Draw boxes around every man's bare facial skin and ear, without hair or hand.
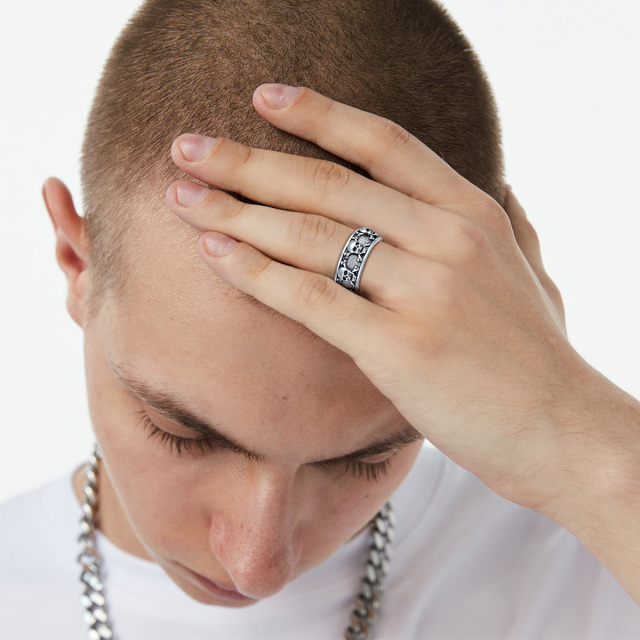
[45,181,422,607]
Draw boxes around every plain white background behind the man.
[0,0,640,499]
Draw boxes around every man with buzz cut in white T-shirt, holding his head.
[3,2,640,640]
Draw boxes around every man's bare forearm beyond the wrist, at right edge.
[547,367,640,604]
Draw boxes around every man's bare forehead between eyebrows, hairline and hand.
[100,218,402,457]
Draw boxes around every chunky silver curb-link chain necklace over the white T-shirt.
[78,446,395,640]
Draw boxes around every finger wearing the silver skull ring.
[167,181,415,306]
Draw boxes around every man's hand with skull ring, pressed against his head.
[167,87,586,510]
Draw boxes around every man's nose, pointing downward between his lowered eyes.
[209,465,301,598]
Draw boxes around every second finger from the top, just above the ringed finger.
[172,134,441,248]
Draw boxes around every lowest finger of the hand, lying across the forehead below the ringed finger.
[198,232,393,362]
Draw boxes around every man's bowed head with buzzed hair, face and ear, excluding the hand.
[47,0,502,605]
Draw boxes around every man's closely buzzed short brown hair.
[82,0,504,310]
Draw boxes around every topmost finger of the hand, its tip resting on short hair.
[253,85,479,204]
